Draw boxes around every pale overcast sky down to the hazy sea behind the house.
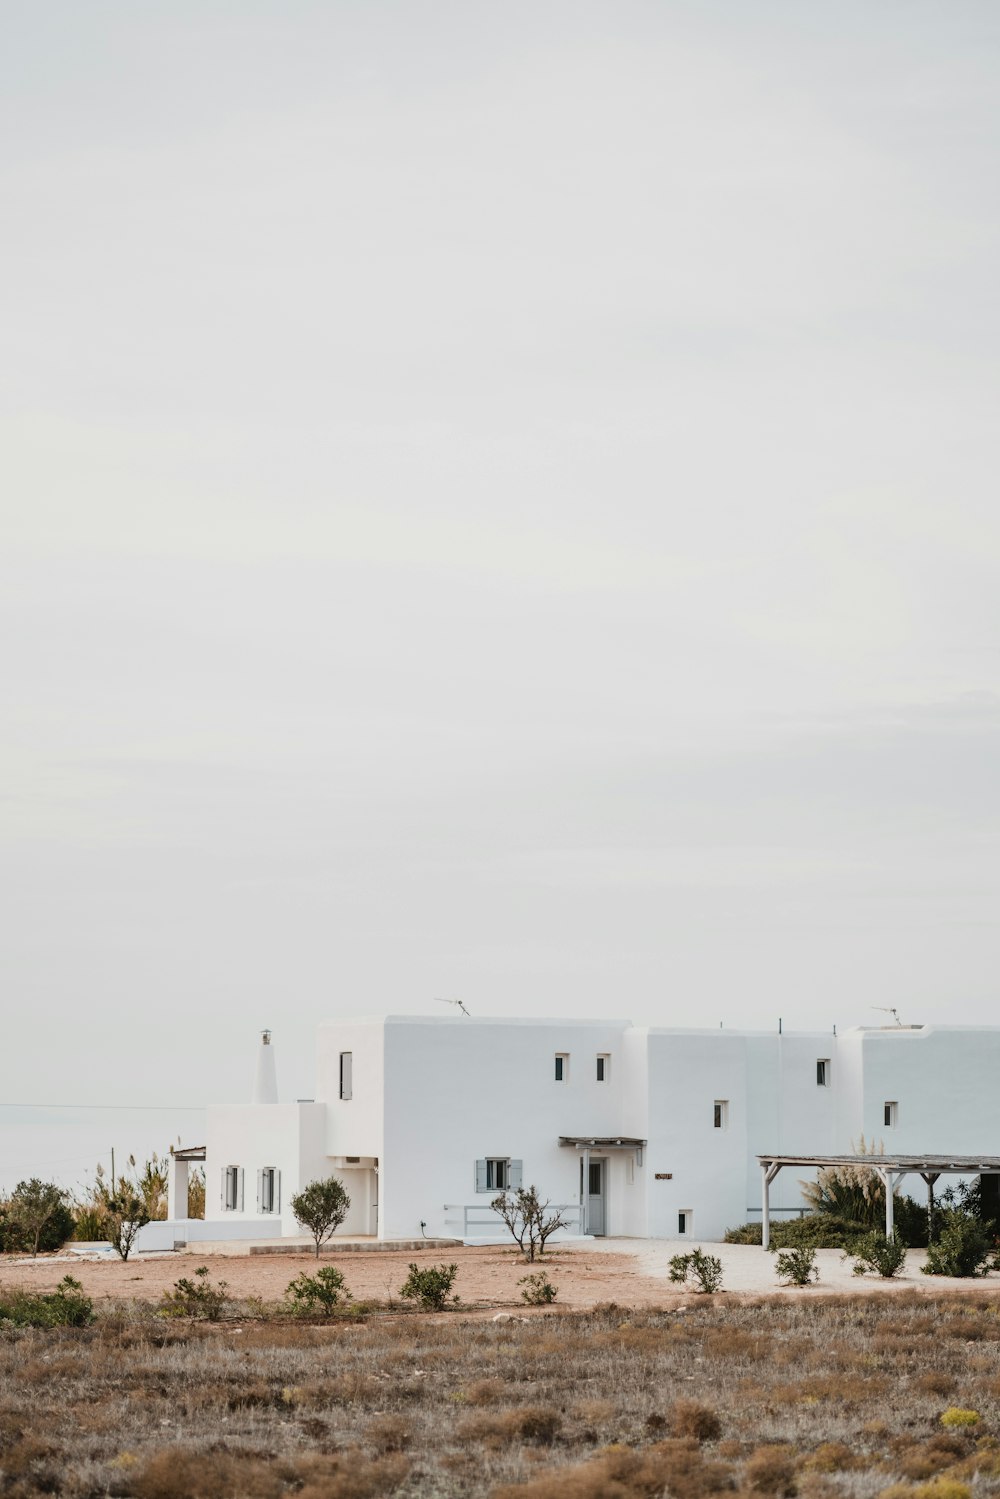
[0,0,1000,1187]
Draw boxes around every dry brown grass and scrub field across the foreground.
[0,1292,1000,1499]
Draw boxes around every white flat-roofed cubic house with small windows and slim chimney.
[156,1015,1000,1240]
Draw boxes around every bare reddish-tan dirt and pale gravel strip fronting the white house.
[0,1240,1000,1310]
